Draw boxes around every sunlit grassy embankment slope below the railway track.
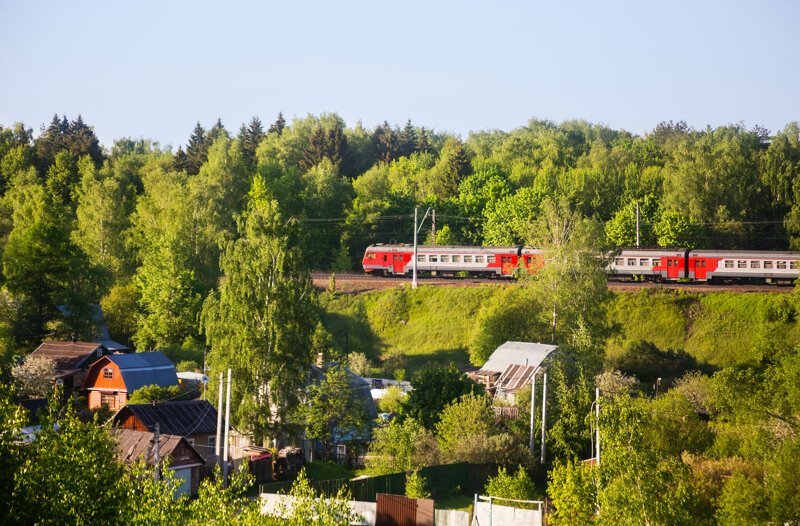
[322,286,800,373]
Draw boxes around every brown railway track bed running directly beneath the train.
[311,272,794,294]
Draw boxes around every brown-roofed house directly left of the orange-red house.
[29,341,111,391]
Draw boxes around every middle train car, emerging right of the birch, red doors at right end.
[607,248,689,281]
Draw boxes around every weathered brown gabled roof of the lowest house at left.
[117,429,204,466]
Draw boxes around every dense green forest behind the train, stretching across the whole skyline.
[0,114,800,358]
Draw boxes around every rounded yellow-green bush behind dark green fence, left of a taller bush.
[366,417,439,475]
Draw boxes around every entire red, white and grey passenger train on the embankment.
[362,243,800,285]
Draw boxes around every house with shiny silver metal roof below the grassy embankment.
[467,342,558,403]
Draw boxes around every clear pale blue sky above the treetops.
[0,0,800,146]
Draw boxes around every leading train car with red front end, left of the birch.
[362,243,541,277]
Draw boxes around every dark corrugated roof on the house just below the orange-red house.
[113,400,217,436]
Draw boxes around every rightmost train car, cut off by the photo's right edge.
[687,250,800,284]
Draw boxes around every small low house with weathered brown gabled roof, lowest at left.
[117,429,203,495]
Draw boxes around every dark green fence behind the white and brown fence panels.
[260,462,497,502]
